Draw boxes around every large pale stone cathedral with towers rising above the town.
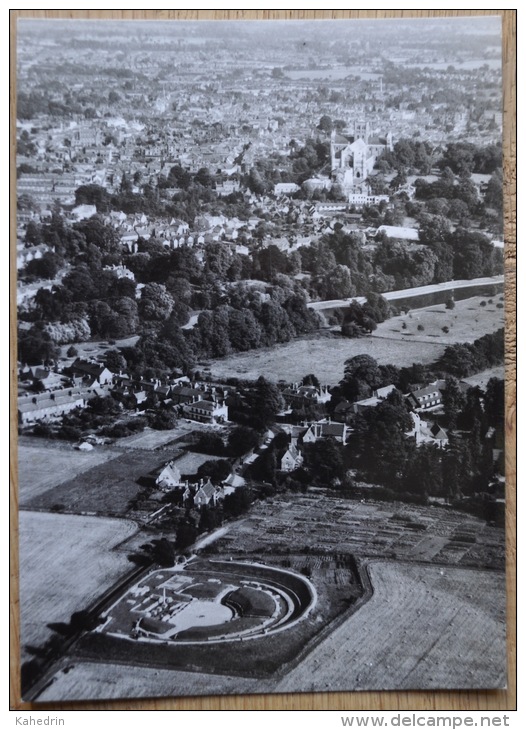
[331,122,393,193]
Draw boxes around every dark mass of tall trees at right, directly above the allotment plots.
[348,378,504,501]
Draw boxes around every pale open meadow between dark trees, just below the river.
[205,297,504,385]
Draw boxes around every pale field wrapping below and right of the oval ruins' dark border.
[39,562,506,701]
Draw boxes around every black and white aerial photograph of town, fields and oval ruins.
[16,15,507,703]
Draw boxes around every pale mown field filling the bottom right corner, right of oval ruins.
[274,563,506,692]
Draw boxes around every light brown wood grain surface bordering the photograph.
[9,10,517,712]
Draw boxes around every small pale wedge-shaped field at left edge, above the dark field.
[18,438,119,507]
